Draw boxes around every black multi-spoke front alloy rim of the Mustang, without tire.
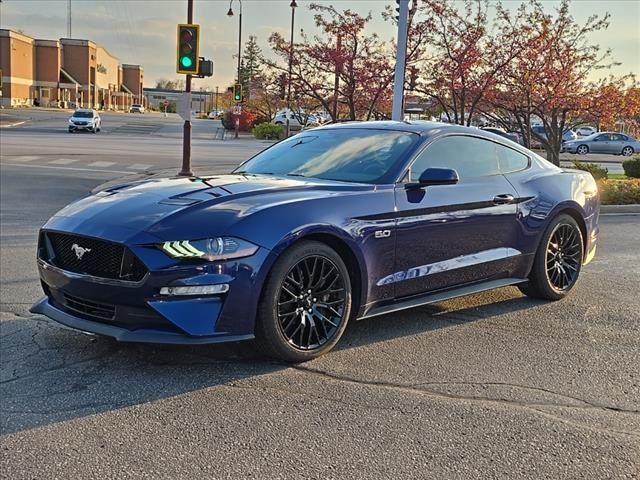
[277,255,346,350]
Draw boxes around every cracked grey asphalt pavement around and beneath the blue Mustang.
[0,113,640,479]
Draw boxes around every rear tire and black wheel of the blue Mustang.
[518,214,584,301]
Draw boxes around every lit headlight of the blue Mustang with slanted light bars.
[160,237,258,261]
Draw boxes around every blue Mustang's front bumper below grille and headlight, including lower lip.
[31,242,271,344]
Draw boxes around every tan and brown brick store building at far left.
[0,30,145,111]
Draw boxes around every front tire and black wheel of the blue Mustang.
[256,241,352,363]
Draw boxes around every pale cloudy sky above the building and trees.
[0,0,640,89]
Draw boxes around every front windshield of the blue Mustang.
[234,128,419,183]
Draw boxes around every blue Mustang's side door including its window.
[387,135,518,298]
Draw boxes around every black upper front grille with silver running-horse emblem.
[39,232,147,282]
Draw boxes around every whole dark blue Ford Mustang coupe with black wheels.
[31,122,599,362]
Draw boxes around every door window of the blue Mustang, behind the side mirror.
[410,135,500,181]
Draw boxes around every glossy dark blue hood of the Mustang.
[44,175,375,243]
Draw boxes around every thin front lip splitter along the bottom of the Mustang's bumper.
[29,297,254,345]
